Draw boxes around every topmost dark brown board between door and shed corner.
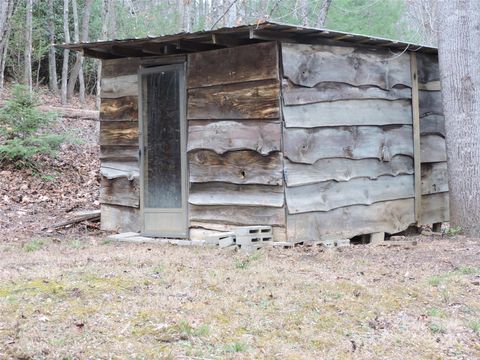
[187,42,279,88]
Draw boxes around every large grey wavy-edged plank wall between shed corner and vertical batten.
[281,43,415,242]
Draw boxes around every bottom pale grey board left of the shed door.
[100,204,140,233]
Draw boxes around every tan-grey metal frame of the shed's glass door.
[138,61,189,238]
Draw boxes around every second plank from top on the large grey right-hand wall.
[282,79,412,106]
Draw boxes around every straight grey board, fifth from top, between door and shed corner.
[188,183,283,207]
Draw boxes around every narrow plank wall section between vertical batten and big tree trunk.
[416,54,449,224]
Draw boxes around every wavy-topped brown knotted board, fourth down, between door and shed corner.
[188,150,283,185]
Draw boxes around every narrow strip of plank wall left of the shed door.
[99,58,140,232]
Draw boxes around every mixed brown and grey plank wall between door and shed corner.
[187,42,285,240]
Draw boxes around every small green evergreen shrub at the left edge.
[0,85,66,168]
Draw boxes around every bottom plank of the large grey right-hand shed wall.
[287,198,415,242]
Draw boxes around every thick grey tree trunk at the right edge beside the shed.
[438,0,480,236]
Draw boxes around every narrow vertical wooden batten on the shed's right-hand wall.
[410,52,422,223]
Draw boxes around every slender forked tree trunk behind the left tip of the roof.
[67,0,93,103]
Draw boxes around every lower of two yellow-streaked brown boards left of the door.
[100,121,138,146]
